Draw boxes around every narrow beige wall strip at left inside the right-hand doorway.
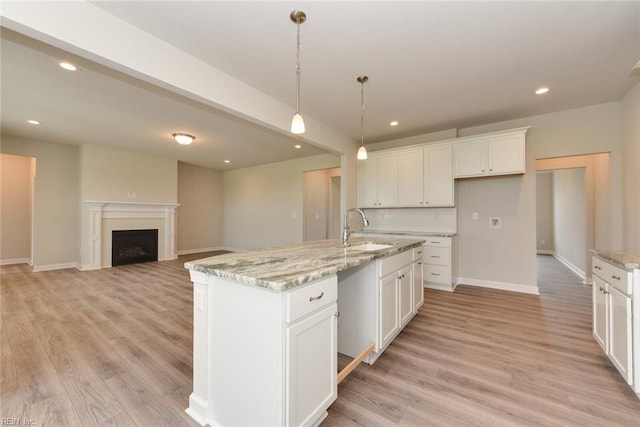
[536,171,553,254]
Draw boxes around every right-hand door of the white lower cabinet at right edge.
[607,286,633,384]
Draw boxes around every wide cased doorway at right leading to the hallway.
[536,153,611,284]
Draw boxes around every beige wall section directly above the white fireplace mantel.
[80,145,178,203]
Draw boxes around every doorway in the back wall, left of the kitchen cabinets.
[303,168,341,241]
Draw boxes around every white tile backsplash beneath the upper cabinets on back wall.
[364,208,457,233]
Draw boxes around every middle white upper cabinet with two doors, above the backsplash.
[398,144,454,207]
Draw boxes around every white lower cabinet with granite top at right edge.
[592,257,640,393]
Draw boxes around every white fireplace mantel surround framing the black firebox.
[80,200,179,270]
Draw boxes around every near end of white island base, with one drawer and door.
[186,270,338,426]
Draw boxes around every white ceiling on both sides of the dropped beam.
[1,1,640,170]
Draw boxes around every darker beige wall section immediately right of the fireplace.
[177,162,224,254]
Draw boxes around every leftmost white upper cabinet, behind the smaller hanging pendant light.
[358,152,398,208]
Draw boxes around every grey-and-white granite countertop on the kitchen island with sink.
[185,237,424,292]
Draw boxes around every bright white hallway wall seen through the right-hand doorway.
[553,168,588,279]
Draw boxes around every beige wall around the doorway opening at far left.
[2,135,80,270]
